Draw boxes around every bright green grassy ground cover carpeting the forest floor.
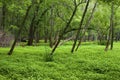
[0,42,120,80]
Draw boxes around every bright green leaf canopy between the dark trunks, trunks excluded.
[0,0,120,47]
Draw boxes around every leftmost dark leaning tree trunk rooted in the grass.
[8,5,32,55]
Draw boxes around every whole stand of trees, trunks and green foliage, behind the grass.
[0,0,120,55]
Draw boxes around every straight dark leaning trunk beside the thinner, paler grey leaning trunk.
[71,0,90,53]
